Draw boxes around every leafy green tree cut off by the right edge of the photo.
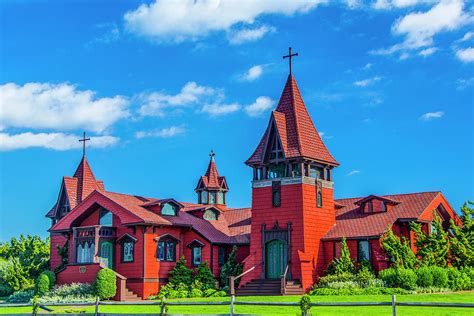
[449,201,474,268]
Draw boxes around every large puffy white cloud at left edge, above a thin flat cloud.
[0,83,129,133]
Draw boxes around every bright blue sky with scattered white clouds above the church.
[0,0,474,241]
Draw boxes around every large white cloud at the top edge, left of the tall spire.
[124,0,326,42]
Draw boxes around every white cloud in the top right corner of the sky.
[372,0,473,55]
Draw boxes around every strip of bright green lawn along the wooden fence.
[0,292,474,316]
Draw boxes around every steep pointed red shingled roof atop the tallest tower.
[246,75,339,166]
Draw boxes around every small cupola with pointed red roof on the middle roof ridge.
[194,150,229,205]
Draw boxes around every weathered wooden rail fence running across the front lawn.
[0,295,474,316]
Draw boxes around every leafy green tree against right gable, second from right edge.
[410,211,449,267]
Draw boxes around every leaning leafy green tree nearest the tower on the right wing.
[380,225,418,269]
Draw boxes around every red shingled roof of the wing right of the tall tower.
[323,192,440,239]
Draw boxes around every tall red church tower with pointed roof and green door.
[244,52,339,290]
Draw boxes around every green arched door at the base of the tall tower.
[265,239,287,279]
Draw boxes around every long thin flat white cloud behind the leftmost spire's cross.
[0,132,119,151]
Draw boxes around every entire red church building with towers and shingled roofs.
[46,60,459,300]
